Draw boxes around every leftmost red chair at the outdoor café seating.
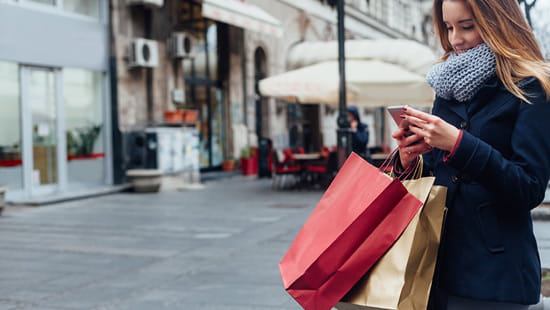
[272,149,302,189]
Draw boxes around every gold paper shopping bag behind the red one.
[336,177,447,310]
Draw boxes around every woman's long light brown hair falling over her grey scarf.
[433,0,550,102]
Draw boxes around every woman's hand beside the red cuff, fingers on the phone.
[402,107,459,152]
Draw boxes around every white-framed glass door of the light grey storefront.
[21,67,66,196]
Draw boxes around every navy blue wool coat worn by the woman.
[430,77,550,304]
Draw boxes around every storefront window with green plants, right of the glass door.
[63,69,105,183]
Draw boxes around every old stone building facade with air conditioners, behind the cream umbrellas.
[111,0,436,182]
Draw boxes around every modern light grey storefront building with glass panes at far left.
[0,0,113,201]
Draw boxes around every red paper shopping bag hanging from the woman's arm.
[279,153,422,310]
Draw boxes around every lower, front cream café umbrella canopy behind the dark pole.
[260,60,434,107]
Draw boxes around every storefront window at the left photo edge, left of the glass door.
[0,61,23,190]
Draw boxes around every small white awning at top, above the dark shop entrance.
[202,0,283,37]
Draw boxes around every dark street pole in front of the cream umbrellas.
[336,0,351,168]
